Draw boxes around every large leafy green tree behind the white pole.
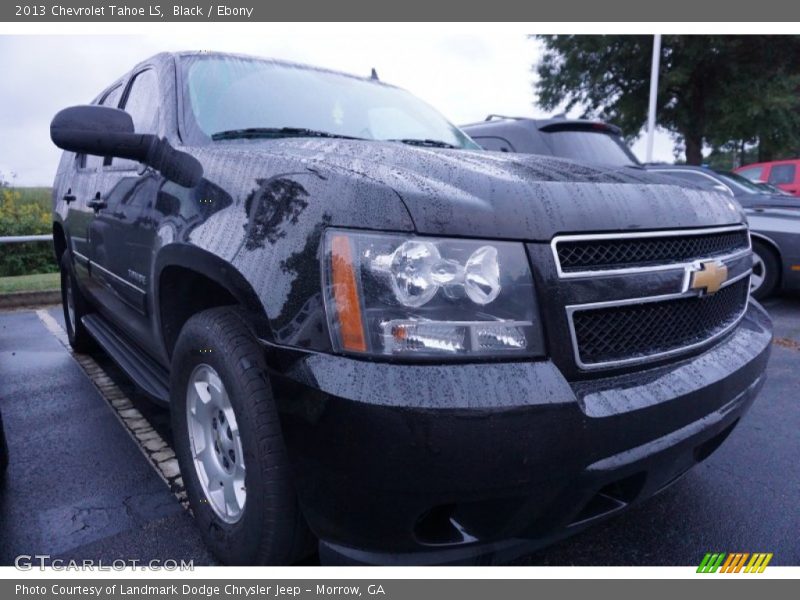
[535,35,800,165]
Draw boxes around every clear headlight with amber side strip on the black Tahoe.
[322,229,543,358]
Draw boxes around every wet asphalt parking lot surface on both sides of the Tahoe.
[0,296,800,565]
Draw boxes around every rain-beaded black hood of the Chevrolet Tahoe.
[208,139,744,241]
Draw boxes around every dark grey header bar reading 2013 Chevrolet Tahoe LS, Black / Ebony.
[0,0,800,23]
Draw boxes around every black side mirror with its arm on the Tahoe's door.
[50,105,203,187]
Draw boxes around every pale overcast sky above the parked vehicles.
[0,29,673,186]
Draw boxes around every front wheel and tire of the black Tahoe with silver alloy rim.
[170,307,314,565]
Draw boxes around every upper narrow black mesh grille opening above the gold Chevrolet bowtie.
[556,229,750,273]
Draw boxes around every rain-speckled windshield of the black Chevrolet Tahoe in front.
[181,55,480,150]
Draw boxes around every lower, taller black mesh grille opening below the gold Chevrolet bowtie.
[572,277,750,367]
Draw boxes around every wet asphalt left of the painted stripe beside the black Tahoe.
[0,308,212,565]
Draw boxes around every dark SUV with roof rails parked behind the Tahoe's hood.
[461,115,639,167]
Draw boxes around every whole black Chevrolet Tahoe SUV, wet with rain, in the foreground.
[51,53,772,564]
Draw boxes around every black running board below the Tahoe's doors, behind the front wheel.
[81,313,169,404]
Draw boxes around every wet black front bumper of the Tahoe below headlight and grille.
[273,303,772,564]
